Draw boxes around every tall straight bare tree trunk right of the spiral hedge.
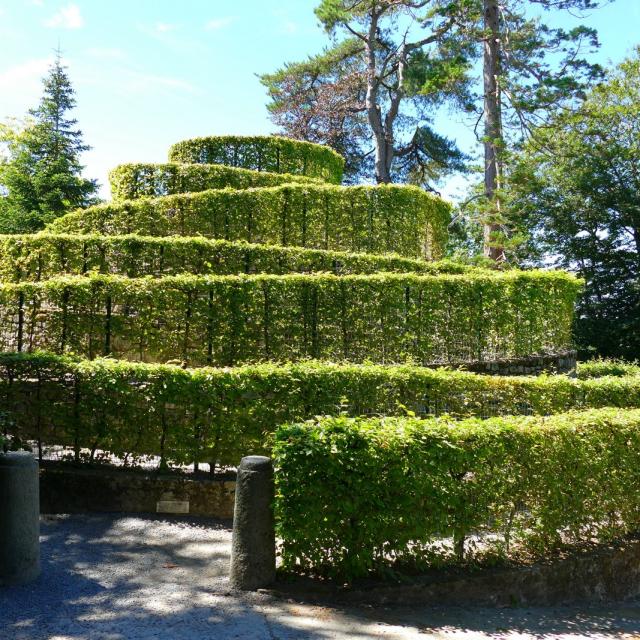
[483,0,505,262]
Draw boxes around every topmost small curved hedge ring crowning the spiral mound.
[169,136,344,184]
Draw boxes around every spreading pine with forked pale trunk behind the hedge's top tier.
[262,0,472,186]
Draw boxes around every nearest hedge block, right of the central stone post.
[274,409,640,580]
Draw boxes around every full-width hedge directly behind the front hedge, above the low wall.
[0,353,640,468]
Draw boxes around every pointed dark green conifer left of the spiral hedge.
[0,52,97,233]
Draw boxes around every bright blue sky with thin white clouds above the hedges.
[0,0,640,197]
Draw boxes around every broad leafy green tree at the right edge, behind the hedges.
[507,53,640,359]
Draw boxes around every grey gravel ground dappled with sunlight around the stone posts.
[0,515,640,640]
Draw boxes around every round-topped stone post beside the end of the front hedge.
[231,456,276,591]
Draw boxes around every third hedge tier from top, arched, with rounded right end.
[48,182,450,258]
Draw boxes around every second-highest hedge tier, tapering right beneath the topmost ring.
[109,162,320,200]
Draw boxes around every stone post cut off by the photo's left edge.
[0,451,40,586]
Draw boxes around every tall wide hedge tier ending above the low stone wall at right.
[0,271,581,366]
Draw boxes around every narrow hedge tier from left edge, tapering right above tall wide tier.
[0,233,472,282]
